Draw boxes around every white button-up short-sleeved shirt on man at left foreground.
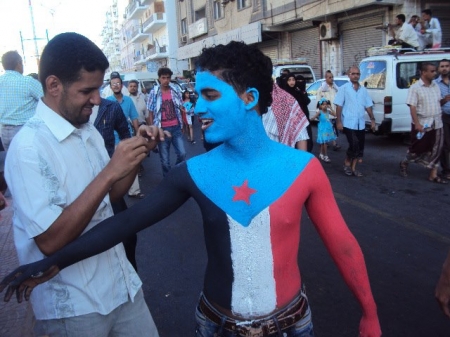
[5,100,142,319]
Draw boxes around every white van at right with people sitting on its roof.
[359,47,450,134]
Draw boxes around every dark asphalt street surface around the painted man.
[128,125,450,337]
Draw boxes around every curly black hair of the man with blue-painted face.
[195,41,273,115]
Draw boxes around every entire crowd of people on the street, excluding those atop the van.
[0,26,450,337]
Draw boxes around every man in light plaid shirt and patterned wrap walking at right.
[400,62,448,184]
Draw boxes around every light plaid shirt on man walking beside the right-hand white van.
[406,79,442,129]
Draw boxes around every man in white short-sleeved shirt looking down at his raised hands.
[5,33,158,337]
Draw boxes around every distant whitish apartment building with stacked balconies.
[102,0,188,78]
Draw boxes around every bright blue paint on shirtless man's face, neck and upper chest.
[187,71,313,226]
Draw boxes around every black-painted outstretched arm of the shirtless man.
[0,166,190,302]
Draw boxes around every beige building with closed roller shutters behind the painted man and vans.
[177,0,450,78]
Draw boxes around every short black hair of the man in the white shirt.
[39,33,109,93]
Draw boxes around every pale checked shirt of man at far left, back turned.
[0,70,44,125]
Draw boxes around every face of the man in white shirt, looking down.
[57,70,105,128]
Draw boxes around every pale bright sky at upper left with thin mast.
[0,0,112,74]
